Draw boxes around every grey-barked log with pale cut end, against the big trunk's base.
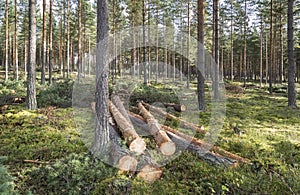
[109,125,138,172]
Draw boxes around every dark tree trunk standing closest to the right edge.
[288,0,297,108]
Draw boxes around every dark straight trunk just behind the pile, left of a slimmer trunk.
[197,0,205,111]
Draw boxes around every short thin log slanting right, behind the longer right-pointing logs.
[143,102,208,134]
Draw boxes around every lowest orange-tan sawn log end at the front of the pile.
[137,165,162,183]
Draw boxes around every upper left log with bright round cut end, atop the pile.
[109,101,146,155]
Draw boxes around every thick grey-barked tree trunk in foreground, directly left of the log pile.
[92,0,109,155]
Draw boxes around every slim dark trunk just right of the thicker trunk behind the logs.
[213,0,219,99]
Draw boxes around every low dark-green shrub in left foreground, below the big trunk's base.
[23,153,116,194]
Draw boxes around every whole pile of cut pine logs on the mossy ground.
[92,96,249,182]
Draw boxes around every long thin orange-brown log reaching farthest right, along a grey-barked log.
[162,126,250,163]
